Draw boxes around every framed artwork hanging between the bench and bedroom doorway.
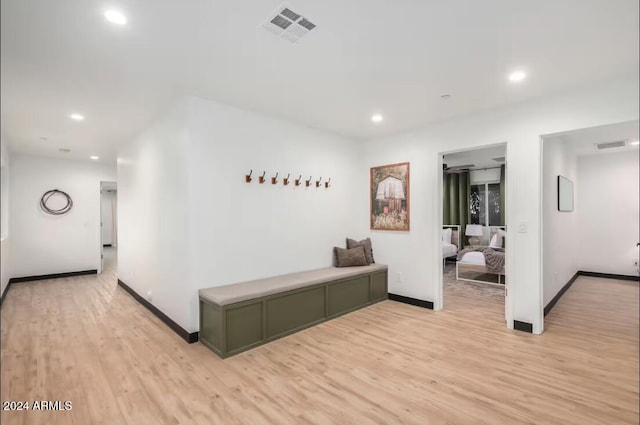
[369,162,409,231]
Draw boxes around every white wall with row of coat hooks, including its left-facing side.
[118,98,368,332]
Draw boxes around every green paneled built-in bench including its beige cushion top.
[199,264,387,358]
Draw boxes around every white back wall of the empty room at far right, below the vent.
[577,150,640,276]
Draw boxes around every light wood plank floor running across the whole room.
[1,256,638,425]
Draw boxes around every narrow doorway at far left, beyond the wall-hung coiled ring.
[99,182,118,273]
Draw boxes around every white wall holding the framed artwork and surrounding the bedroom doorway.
[358,76,638,333]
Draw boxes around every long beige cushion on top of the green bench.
[198,264,387,306]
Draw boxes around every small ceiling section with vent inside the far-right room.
[544,121,640,156]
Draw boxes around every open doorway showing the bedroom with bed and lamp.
[436,143,512,324]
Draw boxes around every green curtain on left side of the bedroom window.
[442,172,471,232]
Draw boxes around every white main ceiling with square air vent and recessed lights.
[1,0,639,161]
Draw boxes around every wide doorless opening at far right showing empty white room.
[541,120,640,322]
